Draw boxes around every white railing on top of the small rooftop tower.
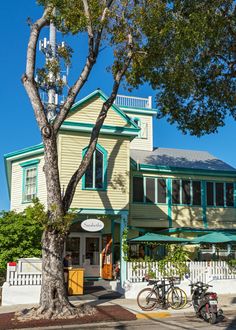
[114,95,152,109]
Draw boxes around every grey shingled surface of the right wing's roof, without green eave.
[131,148,236,171]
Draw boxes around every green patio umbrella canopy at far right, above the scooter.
[189,232,236,244]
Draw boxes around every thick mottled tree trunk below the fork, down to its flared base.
[31,132,77,318]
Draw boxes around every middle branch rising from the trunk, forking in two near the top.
[53,0,113,134]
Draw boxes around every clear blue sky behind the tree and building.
[0,0,236,210]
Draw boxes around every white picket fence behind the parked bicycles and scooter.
[127,261,236,283]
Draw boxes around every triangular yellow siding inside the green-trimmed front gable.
[66,97,130,127]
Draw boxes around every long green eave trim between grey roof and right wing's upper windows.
[139,164,236,178]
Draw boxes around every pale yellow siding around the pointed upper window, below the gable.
[59,132,130,210]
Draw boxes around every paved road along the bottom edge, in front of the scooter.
[67,313,236,330]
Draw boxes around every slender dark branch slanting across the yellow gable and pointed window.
[63,35,134,212]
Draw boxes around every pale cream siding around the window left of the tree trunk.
[10,156,47,212]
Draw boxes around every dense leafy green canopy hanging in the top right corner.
[128,0,236,136]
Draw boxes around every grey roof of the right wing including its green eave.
[130,148,236,176]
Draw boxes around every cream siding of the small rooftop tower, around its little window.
[128,114,153,151]
